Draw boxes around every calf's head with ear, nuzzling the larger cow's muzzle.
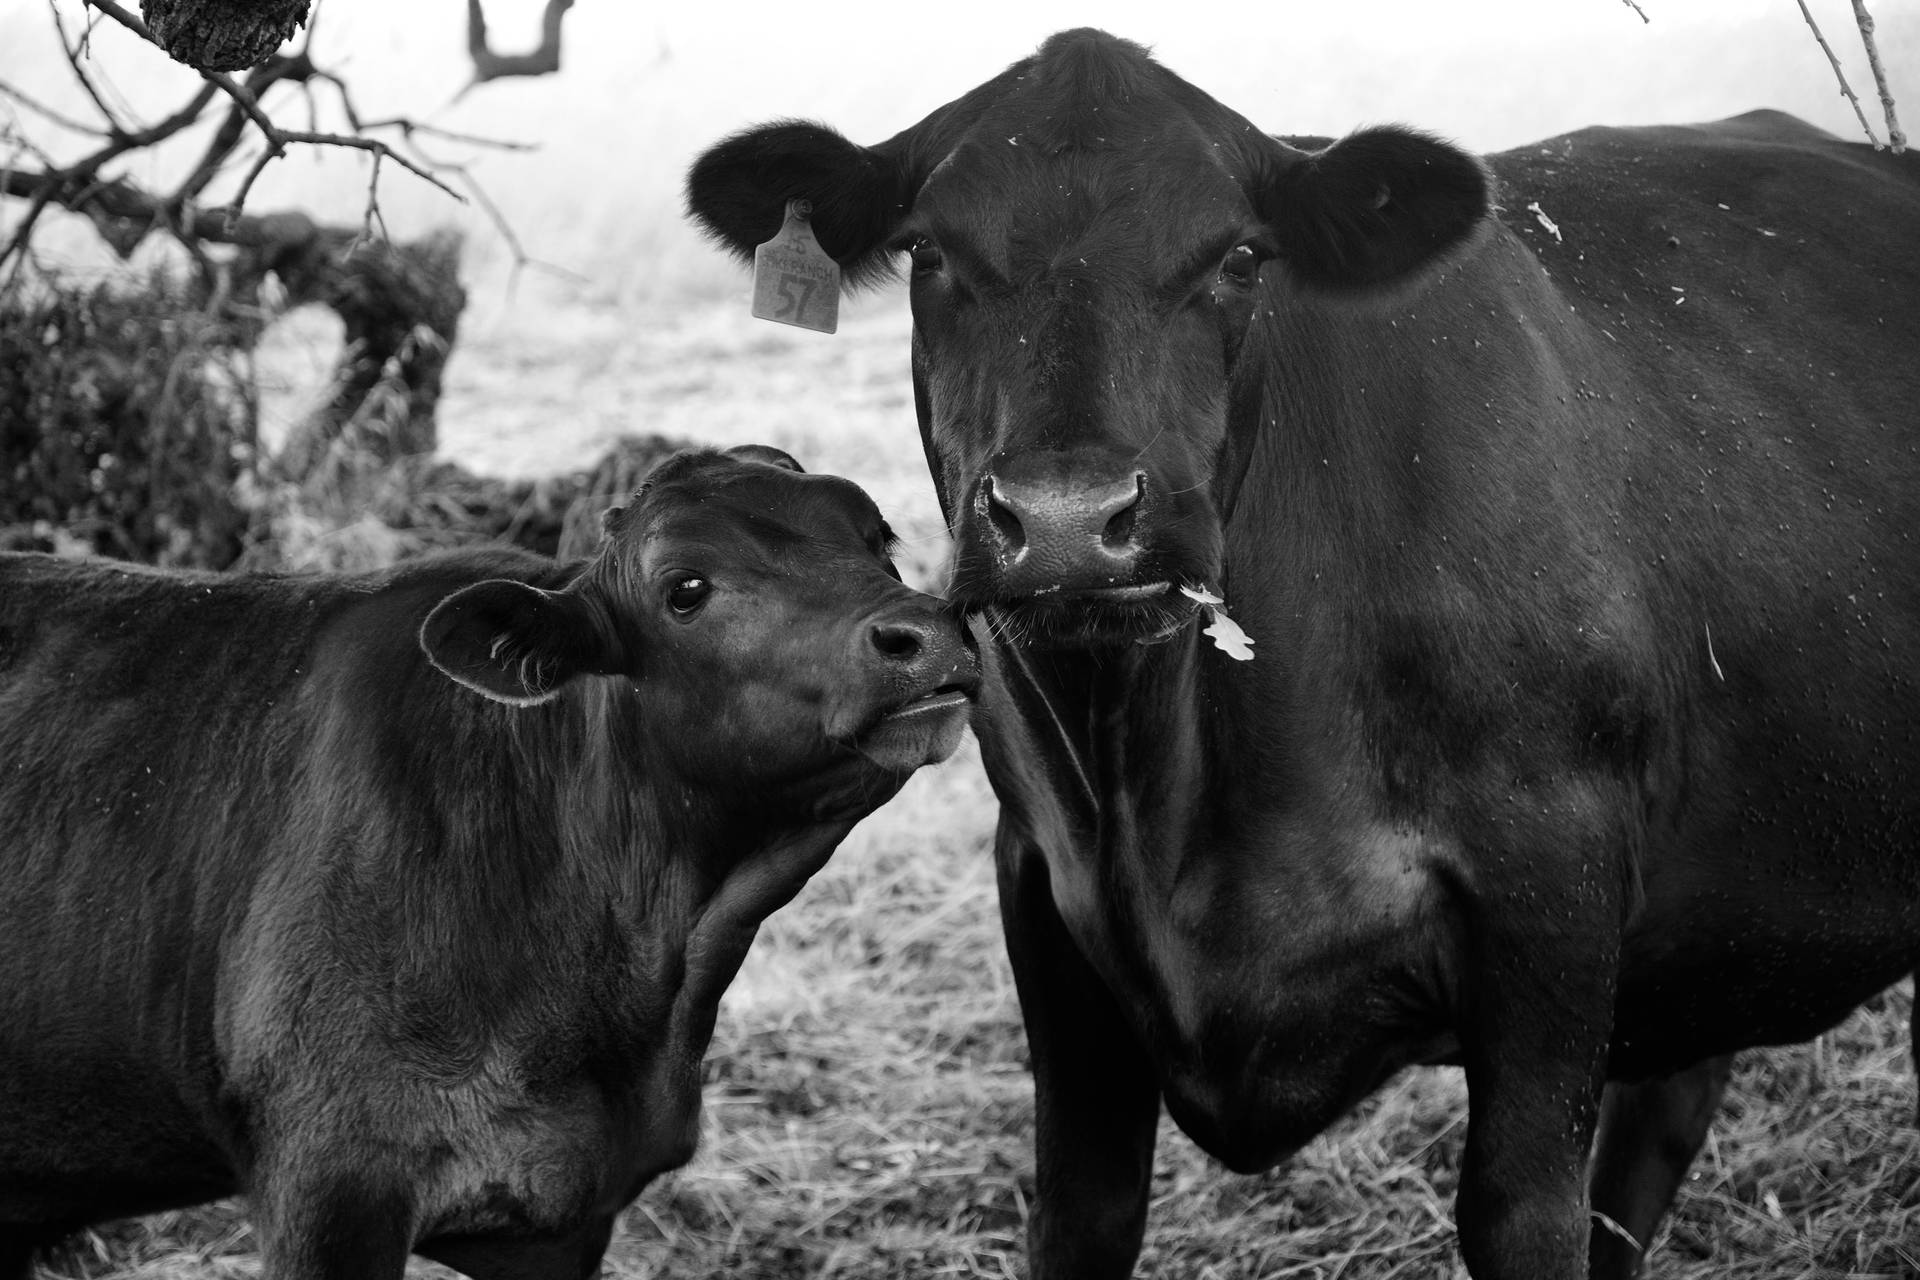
[420,445,977,798]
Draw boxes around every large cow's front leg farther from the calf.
[1457,840,1620,1280]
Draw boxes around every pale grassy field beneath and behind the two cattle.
[11,6,1920,1280]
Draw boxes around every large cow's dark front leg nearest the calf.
[995,819,1160,1280]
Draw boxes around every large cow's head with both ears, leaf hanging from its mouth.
[687,31,1490,645]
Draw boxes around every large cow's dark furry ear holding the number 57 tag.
[687,121,908,286]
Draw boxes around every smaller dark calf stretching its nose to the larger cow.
[0,447,977,1280]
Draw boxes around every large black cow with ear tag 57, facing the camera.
[689,31,1920,1280]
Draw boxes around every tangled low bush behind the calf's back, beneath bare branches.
[0,274,684,570]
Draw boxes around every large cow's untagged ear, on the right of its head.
[1256,127,1494,292]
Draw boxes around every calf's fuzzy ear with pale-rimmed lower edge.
[420,578,622,706]
